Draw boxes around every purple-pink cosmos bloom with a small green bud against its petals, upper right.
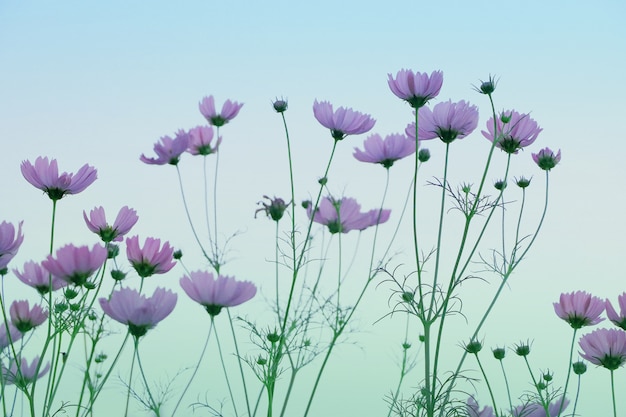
[482,110,543,153]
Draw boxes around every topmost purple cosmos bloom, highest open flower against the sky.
[387,69,443,109]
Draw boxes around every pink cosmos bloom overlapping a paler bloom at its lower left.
[41,244,108,288]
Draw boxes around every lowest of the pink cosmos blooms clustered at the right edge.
[578,329,626,371]
